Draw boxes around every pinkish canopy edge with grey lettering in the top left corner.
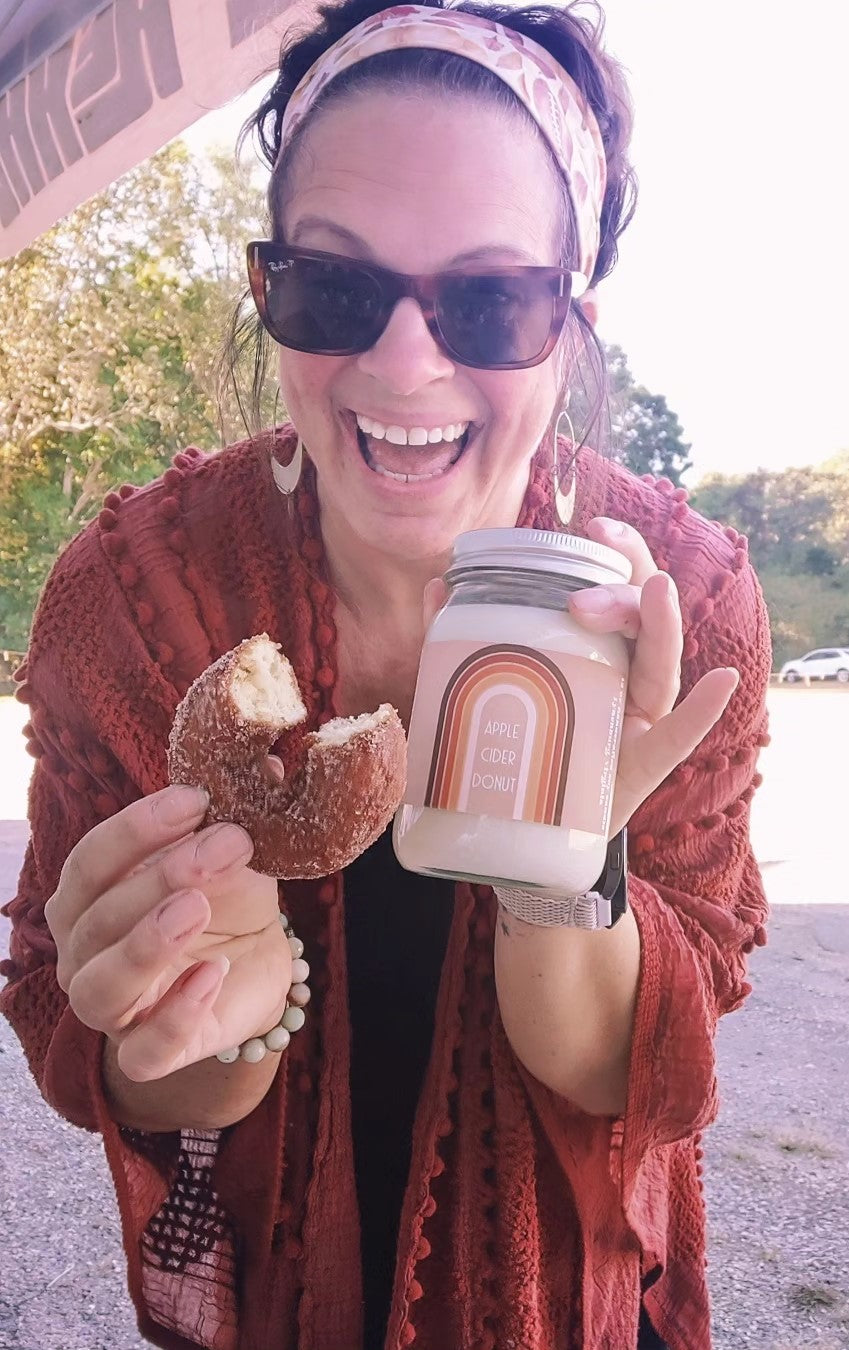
[0,0,305,258]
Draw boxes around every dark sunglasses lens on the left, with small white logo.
[266,258,383,354]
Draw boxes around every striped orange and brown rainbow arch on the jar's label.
[424,644,575,825]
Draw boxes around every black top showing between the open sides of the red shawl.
[344,830,667,1350]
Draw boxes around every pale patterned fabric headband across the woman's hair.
[281,4,607,293]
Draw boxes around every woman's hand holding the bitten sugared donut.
[45,787,292,1083]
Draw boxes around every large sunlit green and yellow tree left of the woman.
[0,142,265,648]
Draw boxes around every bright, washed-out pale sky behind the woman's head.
[186,0,849,483]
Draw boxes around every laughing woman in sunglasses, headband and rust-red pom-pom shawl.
[3,0,769,1350]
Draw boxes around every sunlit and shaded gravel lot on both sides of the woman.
[0,689,849,1350]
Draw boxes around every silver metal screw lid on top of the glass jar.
[448,528,632,585]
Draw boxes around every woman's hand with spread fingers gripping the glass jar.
[568,516,740,836]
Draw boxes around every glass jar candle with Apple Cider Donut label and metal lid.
[393,529,630,896]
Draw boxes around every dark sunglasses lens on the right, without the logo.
[436,273,556,367]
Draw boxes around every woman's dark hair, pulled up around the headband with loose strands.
[225,0,637,440]
